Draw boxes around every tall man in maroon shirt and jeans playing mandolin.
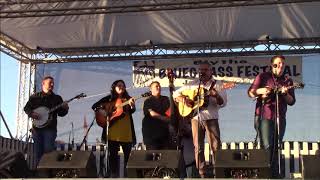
[248,55,303,176]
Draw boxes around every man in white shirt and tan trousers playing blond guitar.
[173,61,227,178]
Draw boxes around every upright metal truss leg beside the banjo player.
[16,62,36,140]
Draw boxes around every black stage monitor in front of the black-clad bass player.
[127,150,182,178]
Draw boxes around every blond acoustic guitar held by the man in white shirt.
[178,82,235,117]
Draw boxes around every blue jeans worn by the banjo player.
[32,129,57,164]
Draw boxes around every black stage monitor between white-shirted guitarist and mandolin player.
[215,149,271,179]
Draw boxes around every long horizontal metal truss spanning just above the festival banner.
[10,38,320,63]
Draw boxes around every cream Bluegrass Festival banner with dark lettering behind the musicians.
[133,56,302,87]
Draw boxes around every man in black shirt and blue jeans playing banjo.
[24,76,69,164]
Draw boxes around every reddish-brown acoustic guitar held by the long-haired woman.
[95,92,151,128]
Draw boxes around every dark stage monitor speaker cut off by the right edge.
[301,155,320,179]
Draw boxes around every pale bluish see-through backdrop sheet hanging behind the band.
[28,55,320,143]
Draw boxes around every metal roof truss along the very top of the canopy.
[0,0,319,18]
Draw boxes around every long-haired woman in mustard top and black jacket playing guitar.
[92,80,136,178]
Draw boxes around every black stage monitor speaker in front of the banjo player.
[38,151,97,178]
